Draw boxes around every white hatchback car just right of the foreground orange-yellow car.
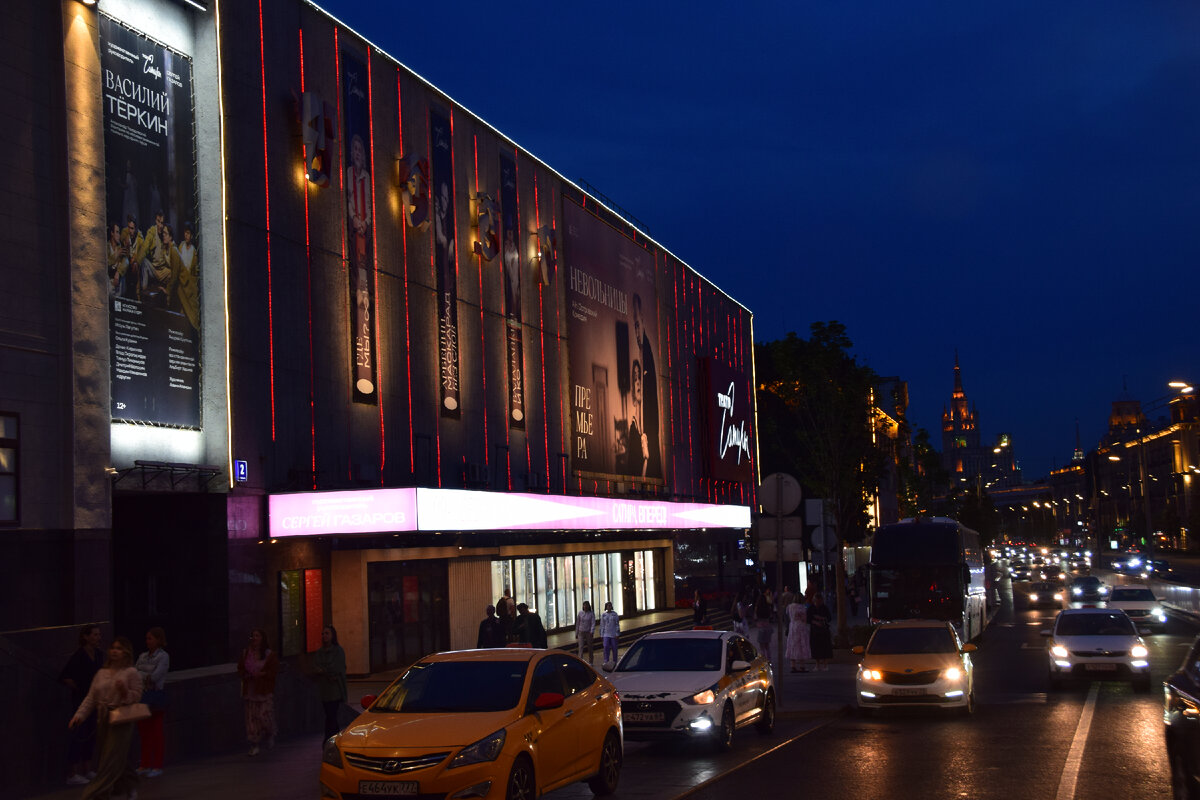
[608,631,775,750]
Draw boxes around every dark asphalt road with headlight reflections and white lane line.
[585,568,1198,800]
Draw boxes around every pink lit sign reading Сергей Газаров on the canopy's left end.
[270,489,416,537]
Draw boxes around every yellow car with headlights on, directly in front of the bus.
[854,619,976,715]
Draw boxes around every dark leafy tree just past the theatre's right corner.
[755,321,884,642]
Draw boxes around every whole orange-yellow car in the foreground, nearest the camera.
[320,648,624,800]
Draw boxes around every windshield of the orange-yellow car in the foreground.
[371,661,529,714]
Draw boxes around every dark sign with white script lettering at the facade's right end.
[700,359,754,482]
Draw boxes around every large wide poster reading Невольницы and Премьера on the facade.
[563,200,662,482]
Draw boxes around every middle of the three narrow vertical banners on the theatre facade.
[430,108,461,416]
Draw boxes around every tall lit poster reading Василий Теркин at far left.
[100,14,200,428]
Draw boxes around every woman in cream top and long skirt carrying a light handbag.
[67,636,150,800]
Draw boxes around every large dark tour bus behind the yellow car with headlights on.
[868,517,988,642]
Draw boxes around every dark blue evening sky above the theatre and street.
[322,0,1200,479]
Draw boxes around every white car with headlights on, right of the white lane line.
[1042,608,1150,692]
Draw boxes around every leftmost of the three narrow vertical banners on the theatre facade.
[341,49,378,403]
